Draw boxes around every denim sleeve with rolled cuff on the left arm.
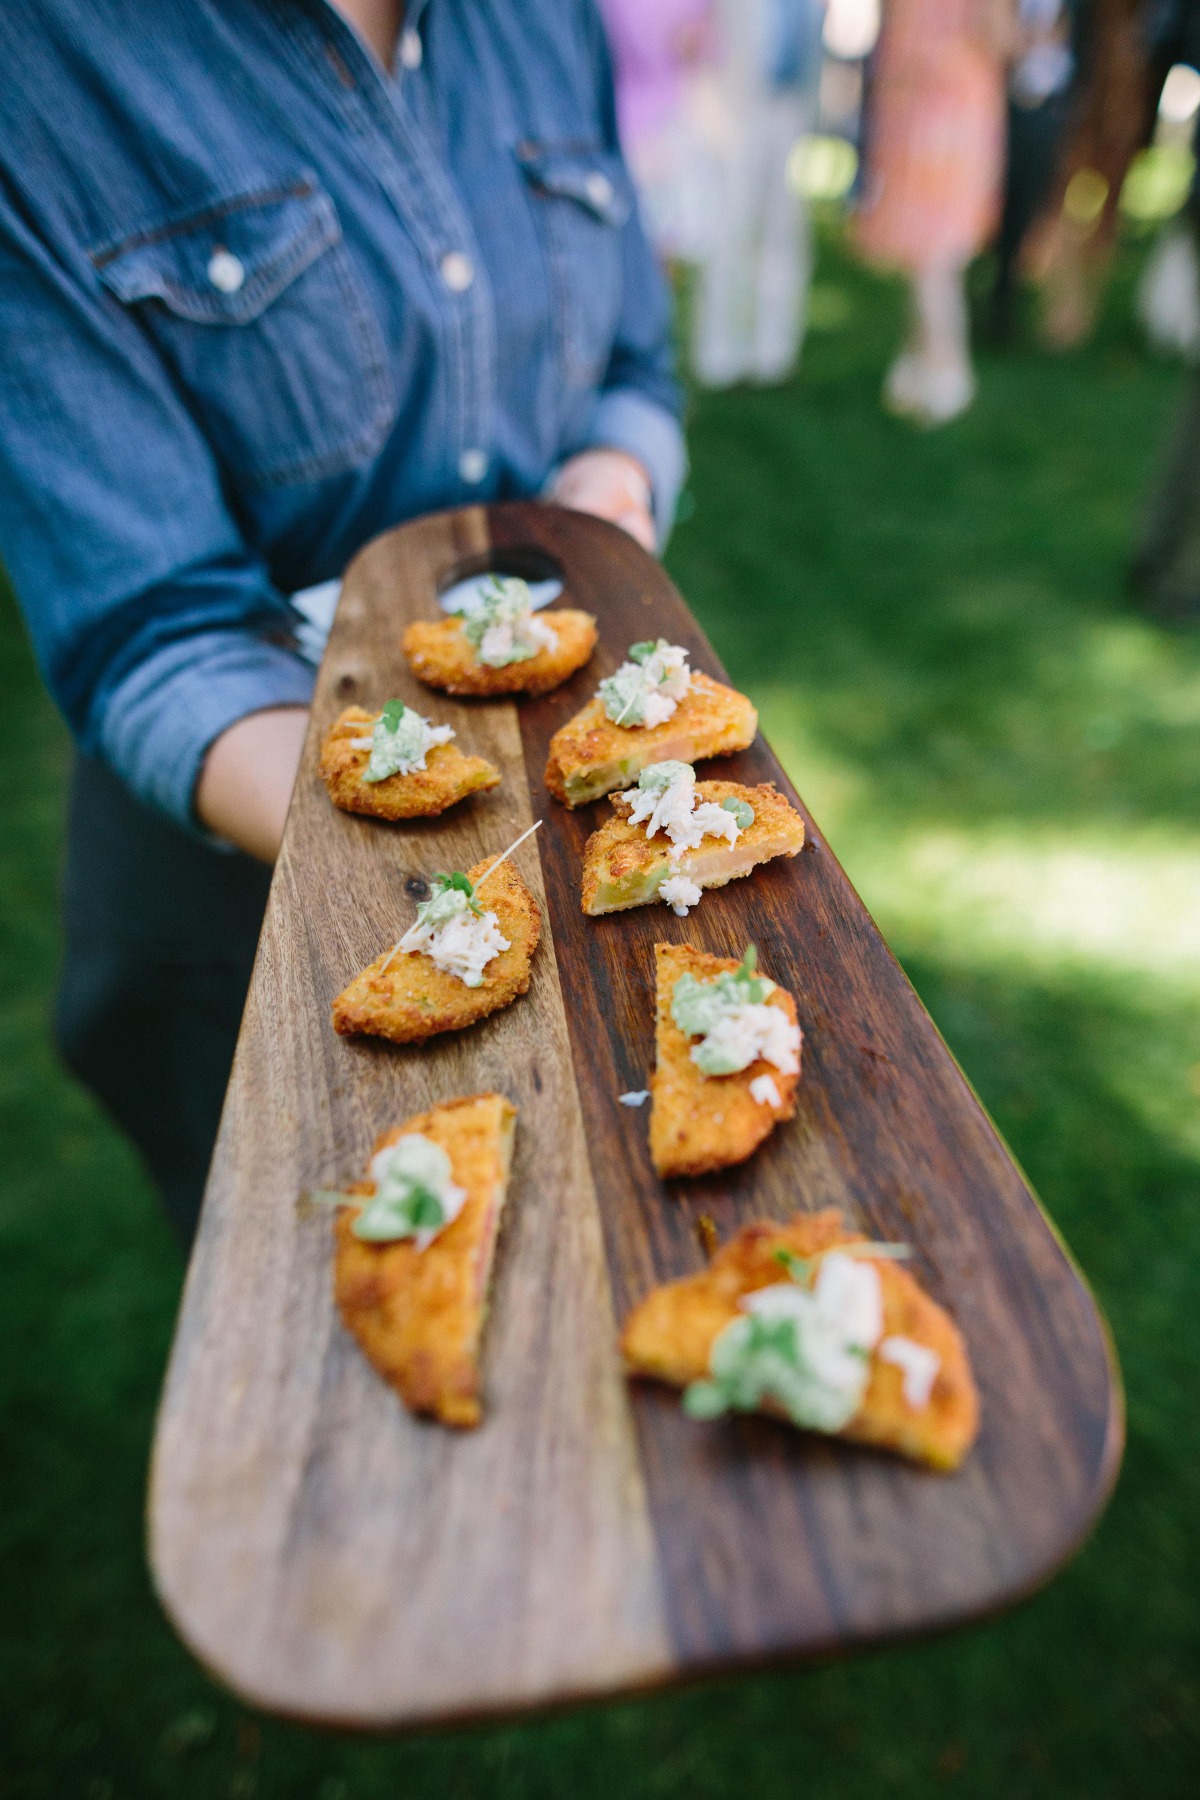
[0,182,311,824]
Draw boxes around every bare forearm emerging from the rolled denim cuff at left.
[196,706,308,862]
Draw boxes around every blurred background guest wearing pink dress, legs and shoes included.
[855,0,1013,425]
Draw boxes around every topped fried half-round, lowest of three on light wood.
[333,1094,516,1426]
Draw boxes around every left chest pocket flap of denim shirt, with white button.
[92,176,342,326]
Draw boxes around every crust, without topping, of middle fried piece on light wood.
[333,857,542,1044]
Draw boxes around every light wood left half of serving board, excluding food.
[151,513,669,1723]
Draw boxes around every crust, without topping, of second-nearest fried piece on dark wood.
[649,943,801,1177]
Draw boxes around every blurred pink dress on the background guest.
[855,0,1004,274]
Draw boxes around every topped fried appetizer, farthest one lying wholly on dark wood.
[545,637,757,806]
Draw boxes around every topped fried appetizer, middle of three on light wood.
[333,833,542,1044]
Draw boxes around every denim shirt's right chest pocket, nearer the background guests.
[515,139,633,389]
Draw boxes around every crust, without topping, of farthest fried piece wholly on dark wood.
[545,670,759,806]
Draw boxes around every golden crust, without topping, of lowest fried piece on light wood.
[333,1094,516,1426]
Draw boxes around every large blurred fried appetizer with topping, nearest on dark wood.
[621,1208,979,1471]
